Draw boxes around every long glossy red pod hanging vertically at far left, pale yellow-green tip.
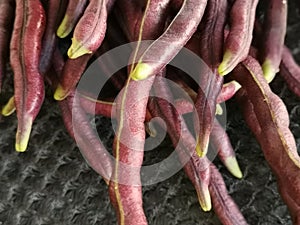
[10,0,45,152]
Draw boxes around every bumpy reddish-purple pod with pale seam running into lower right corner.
[234,57,300,224]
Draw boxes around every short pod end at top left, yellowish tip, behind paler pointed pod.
[56,0,88,38]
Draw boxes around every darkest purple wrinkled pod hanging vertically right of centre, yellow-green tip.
[195,0,227,157]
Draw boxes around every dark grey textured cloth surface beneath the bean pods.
[0,0,300,225]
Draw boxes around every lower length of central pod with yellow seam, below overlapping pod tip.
[109,76,154,225]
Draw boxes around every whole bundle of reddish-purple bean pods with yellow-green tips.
[0,0,300,225]
